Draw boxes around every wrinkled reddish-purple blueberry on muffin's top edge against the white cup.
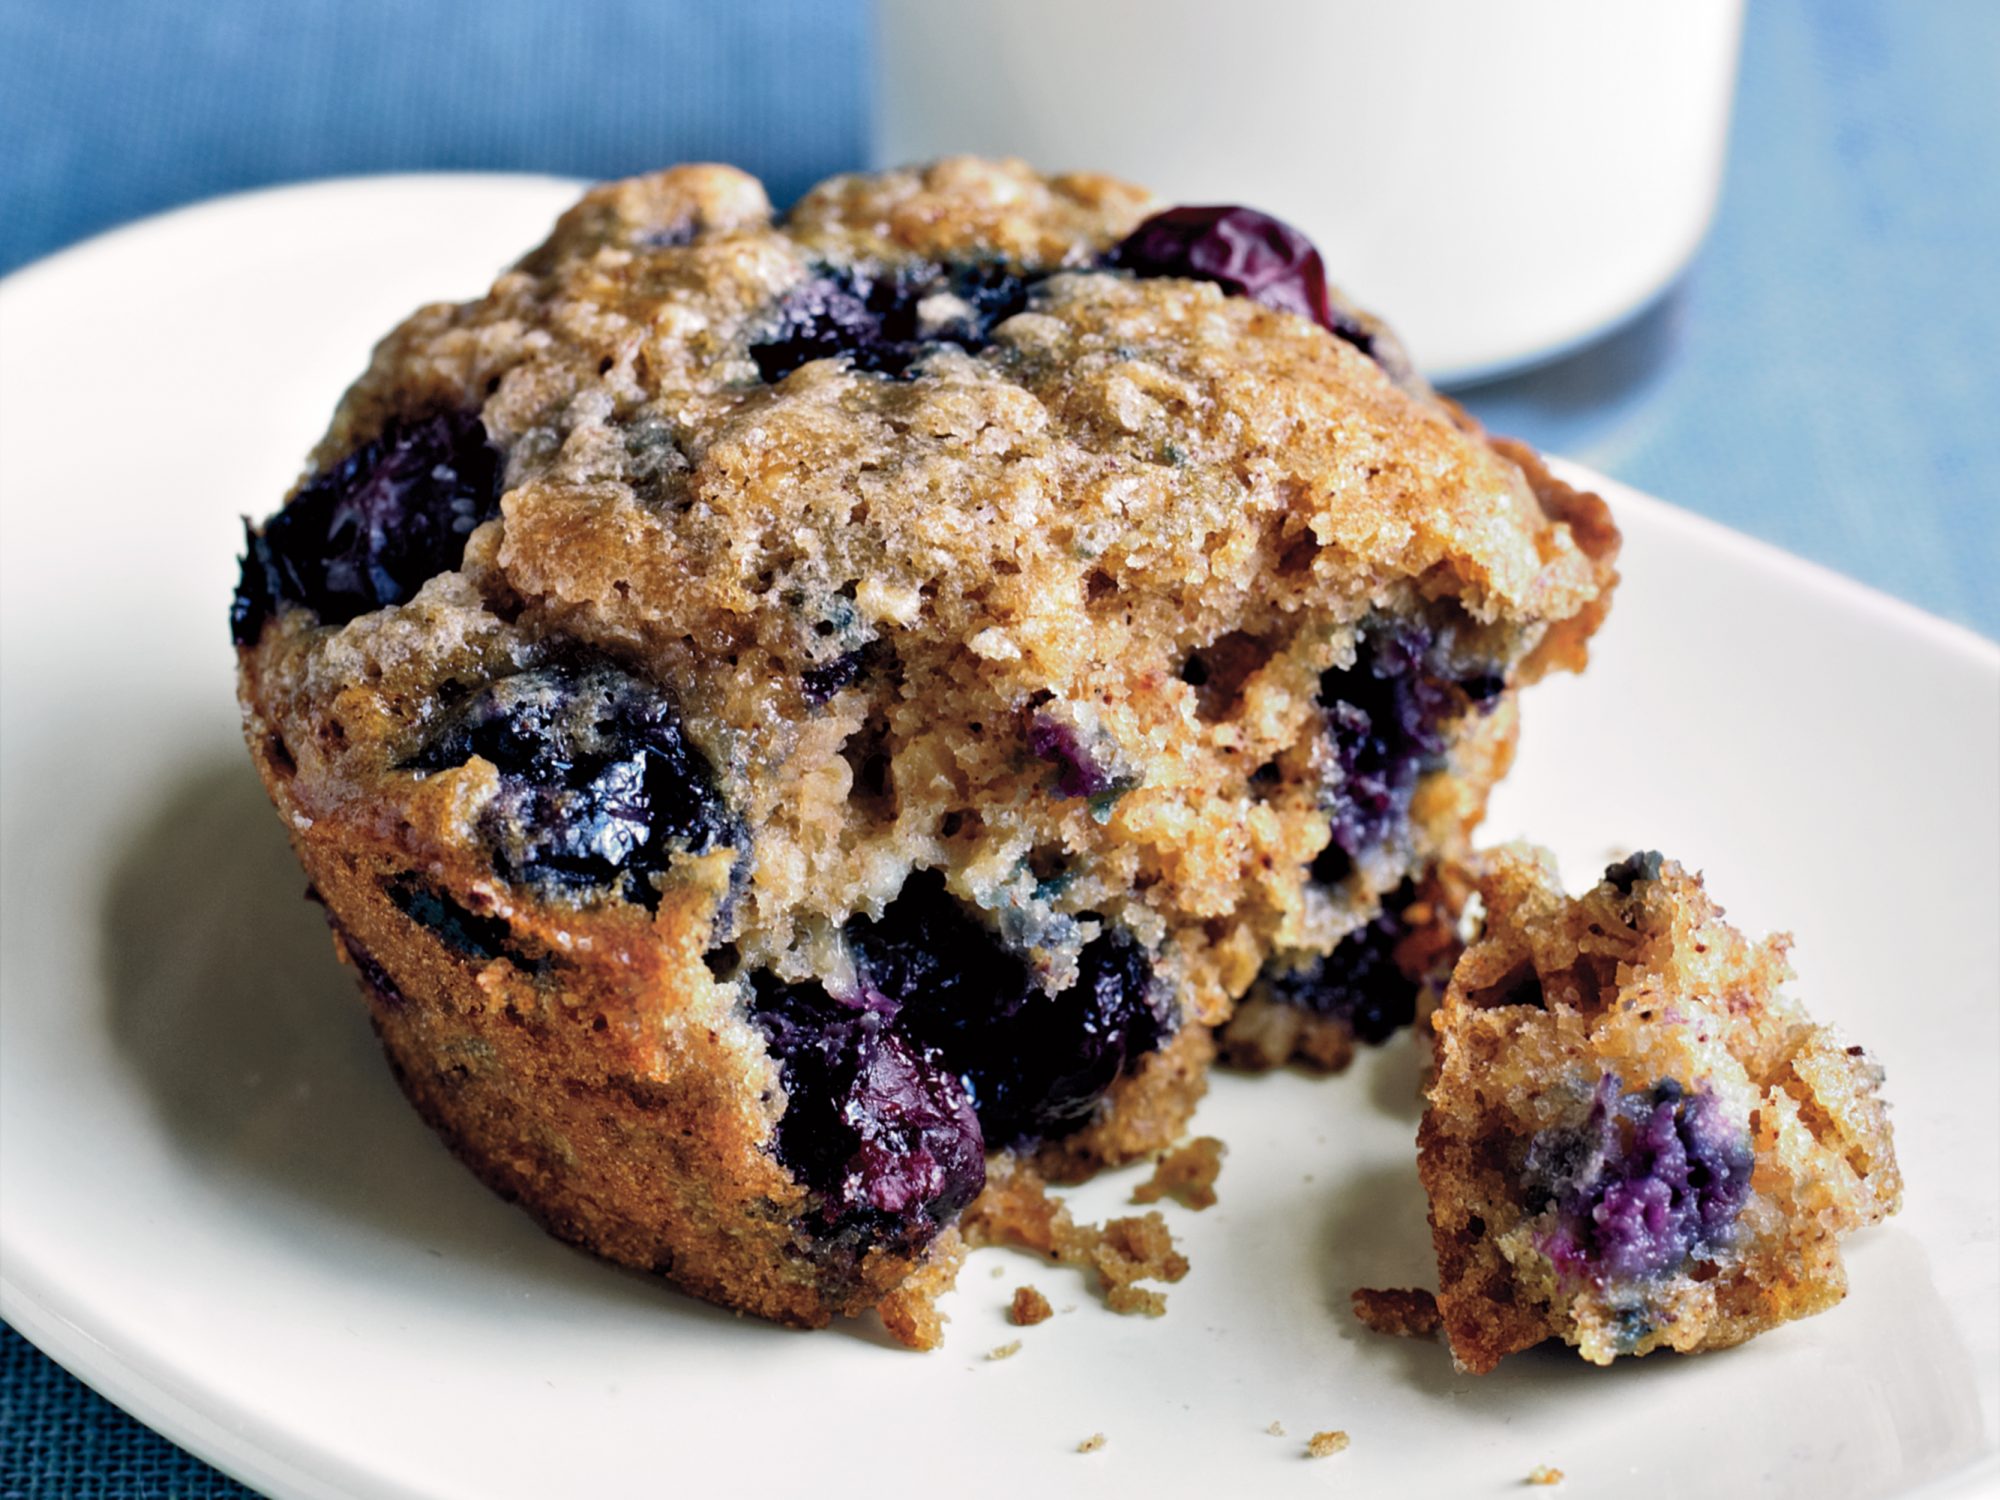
[1106,204,1376,358]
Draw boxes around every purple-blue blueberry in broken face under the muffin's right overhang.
[1312,628,1466,884]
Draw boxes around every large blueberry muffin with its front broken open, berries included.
[232,160,1616,1344]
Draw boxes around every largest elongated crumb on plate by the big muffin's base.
[960,1158,1188,1318]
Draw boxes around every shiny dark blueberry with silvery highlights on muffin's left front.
[406,664,740,908]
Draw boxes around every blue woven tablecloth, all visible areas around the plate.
[0,0,2000,1500]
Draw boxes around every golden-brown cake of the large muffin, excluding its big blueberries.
[240,160,1616,1342]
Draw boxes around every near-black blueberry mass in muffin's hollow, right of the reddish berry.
[848,872,1172,1146]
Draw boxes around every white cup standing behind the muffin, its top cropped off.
[874,0,1742,382]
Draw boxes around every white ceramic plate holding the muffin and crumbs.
[0,178,2000,1500]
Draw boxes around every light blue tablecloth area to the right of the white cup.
[1464,0,2000,636]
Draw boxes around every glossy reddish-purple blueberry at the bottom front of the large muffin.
[750,974,986,1254]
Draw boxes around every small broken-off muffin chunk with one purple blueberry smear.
[1418,848,1902,1372]
